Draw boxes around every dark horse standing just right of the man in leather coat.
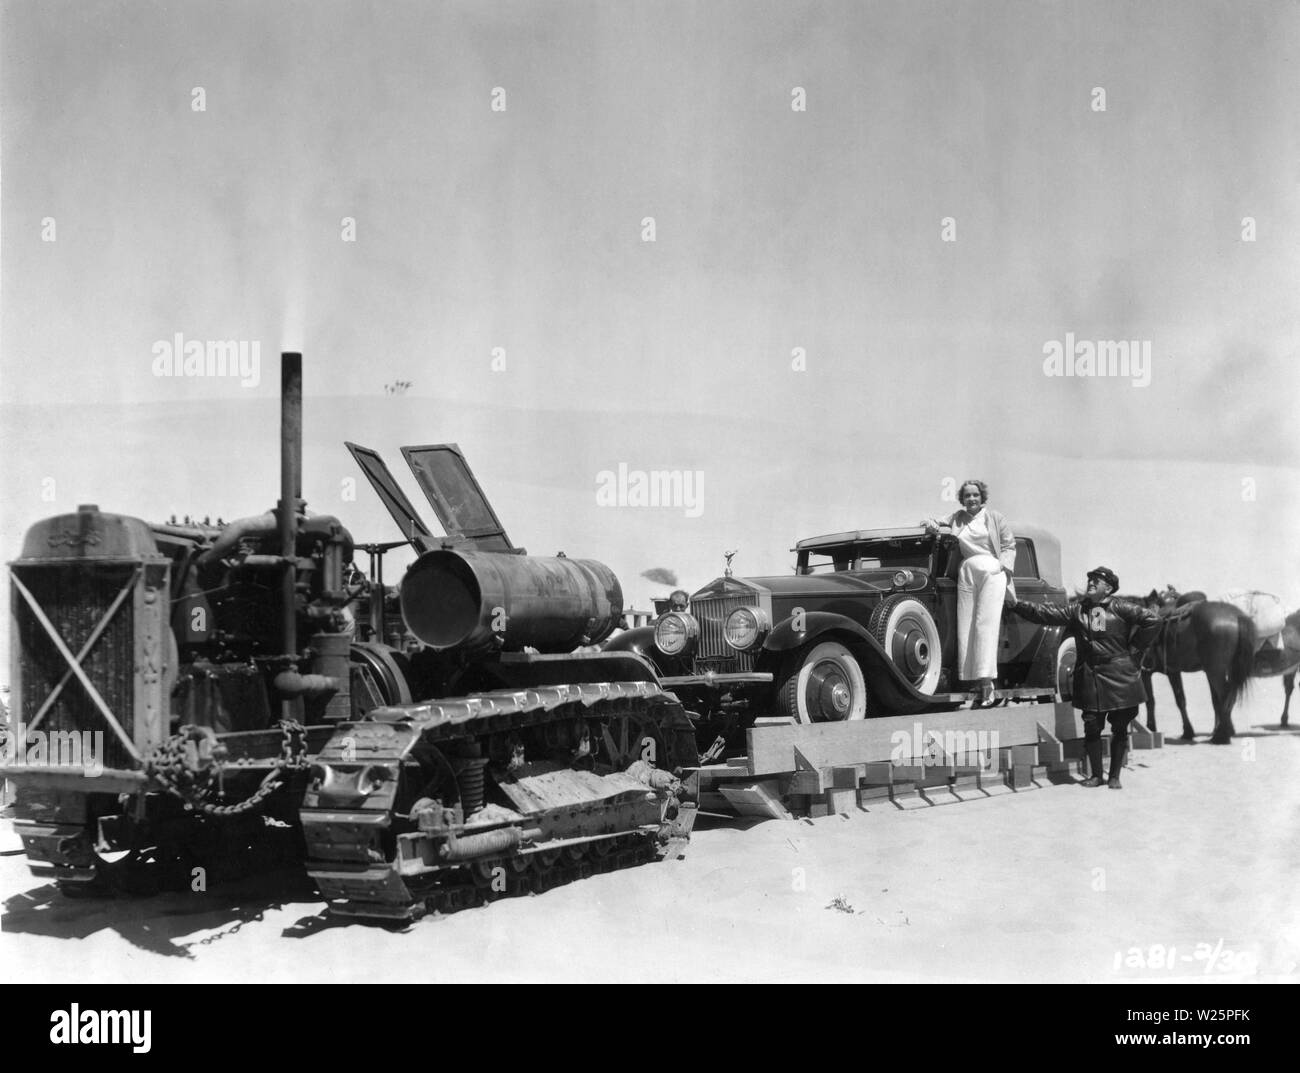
[1138,587,1256,745]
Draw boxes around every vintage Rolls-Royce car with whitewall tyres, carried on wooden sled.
[608,525,1073,723]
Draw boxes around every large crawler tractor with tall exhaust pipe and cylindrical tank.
[0,354,698,920]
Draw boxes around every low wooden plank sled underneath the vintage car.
[689,698,1164,819]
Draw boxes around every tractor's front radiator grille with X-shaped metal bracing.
[12,563,135,767]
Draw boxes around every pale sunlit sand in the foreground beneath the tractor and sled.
[0,678,1300,982]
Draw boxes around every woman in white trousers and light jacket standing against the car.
[924,480,1015,708]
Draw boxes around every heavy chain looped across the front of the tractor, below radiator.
[144,719,307,817]
